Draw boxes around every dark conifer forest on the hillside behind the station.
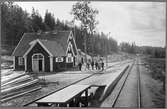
[1,2,165,58]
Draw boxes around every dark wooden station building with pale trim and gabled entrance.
[12,31,78,72]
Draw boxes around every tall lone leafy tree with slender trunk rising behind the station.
[71,1,98,53]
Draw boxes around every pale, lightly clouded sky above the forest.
[15,1,166,47]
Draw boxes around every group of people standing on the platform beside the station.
[78,58,104,71]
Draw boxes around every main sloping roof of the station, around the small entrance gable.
[12,31,71,56]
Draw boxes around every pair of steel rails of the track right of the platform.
[111,59,142,108]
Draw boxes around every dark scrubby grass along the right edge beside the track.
[143,58,165,107]
